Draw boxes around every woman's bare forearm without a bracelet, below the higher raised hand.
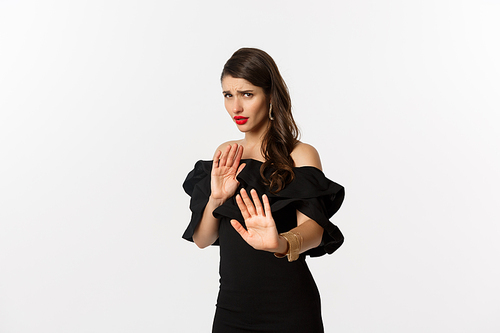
[193,196,224,249]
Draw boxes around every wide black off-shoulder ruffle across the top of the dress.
[182,159,345,257]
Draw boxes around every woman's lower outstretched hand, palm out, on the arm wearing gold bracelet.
[231,189,279,252]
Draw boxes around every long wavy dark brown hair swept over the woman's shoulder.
[221,48,299,193]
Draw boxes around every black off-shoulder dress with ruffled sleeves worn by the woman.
[183,159,344,333]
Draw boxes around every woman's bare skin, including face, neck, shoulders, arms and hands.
[193,76,323,253]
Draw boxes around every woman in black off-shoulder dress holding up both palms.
[183,48,344,333]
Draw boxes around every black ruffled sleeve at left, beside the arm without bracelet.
[182,161,218,245]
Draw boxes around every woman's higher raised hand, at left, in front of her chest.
[211,143,245,202]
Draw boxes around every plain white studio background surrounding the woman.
[0,0,500,333]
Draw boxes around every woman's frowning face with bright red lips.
[222,76,270,132]
